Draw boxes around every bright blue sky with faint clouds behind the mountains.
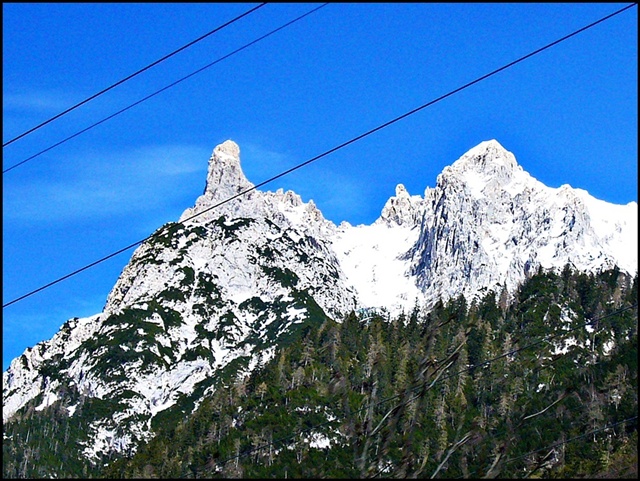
[2,3,638,370]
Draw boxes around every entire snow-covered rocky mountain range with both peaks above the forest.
[3,140,638,458]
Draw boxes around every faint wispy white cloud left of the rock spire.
[3,145,208,223]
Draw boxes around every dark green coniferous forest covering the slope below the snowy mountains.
[3,267,638,479]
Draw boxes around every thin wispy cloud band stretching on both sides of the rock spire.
[3,139,382,227]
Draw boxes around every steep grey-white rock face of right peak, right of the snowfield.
[405,140,637,303]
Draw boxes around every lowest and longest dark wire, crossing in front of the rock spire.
[2,3,637,309]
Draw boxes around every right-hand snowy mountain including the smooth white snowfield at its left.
[332,140,638,311]
